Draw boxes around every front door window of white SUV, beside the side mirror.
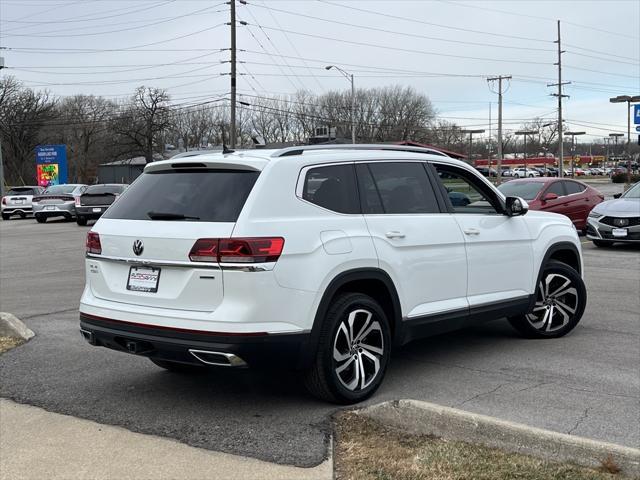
[434,164,502,214]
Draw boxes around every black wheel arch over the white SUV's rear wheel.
[299,268,402,368]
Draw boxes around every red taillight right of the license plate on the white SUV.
[189,237,284,263]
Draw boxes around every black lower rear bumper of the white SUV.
[80,313,310,369]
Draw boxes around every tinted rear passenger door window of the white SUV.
[366,162,440,213]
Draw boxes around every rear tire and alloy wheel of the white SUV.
[304,293,391,404]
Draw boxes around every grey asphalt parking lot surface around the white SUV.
[0,219,640,466]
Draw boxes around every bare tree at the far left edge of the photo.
[0,76,56,184]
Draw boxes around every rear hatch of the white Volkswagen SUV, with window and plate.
[87,168,260,312]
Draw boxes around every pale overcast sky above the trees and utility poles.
[0,0,640,144]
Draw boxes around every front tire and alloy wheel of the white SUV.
[508,260,587,338]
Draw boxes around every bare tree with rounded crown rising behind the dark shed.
[112,87,171,163]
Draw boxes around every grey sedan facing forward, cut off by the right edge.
[587,183,640,247]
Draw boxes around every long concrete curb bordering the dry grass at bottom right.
[358,400,640,476]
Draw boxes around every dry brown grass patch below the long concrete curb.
[335,412,621,480]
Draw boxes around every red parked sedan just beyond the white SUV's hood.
[498,177,604,231]
